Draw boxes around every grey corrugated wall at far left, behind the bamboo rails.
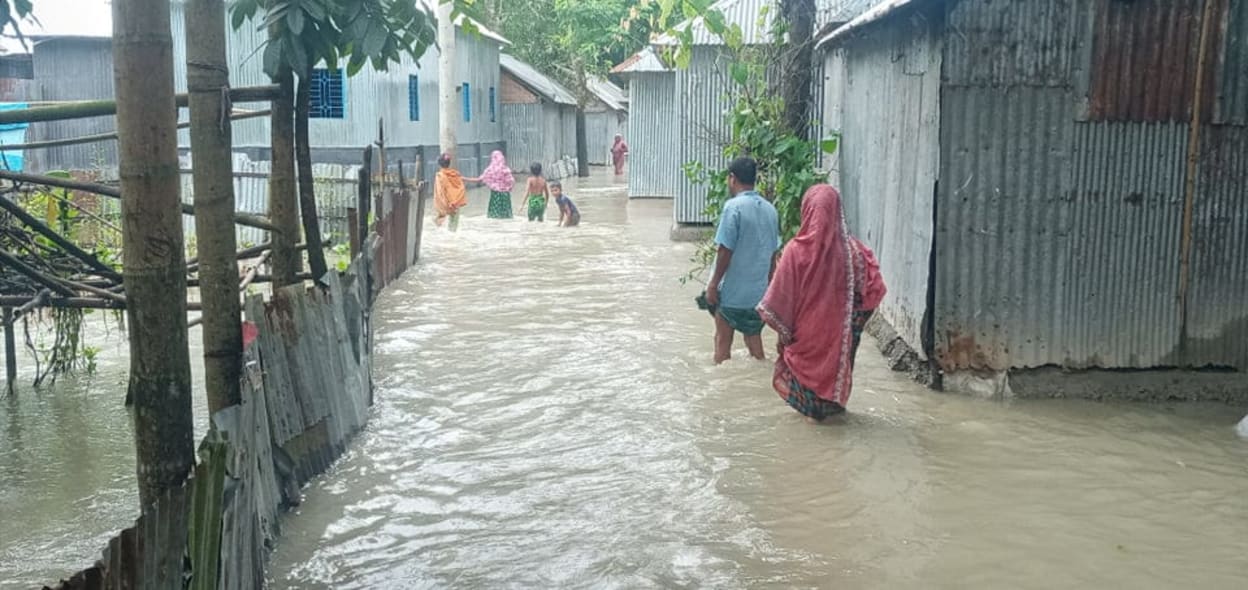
[25,39,117,172]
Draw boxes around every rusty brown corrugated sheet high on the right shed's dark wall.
[1088,0,1228,121]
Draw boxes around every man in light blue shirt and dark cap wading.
[706,157,780,364]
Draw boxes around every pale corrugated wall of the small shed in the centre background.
[626,72,680,198]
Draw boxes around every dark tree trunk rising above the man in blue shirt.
[780,0,815,140]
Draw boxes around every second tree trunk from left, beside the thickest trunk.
[186,0,242,414]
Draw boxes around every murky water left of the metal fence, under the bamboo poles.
[0,313,207,589]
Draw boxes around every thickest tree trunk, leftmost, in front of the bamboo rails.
[112,0,195,508]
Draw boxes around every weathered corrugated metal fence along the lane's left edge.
[43,182,423,590]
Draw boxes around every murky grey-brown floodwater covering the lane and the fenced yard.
[0,172,1248,589]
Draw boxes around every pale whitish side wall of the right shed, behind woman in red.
[827,11,941,354]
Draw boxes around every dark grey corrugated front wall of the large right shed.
[933,0,1248,370]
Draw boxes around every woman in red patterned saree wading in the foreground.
[759,185,886,420]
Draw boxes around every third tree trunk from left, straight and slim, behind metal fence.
[268,67,302,288]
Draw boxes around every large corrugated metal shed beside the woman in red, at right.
[820,0,1248,387]
